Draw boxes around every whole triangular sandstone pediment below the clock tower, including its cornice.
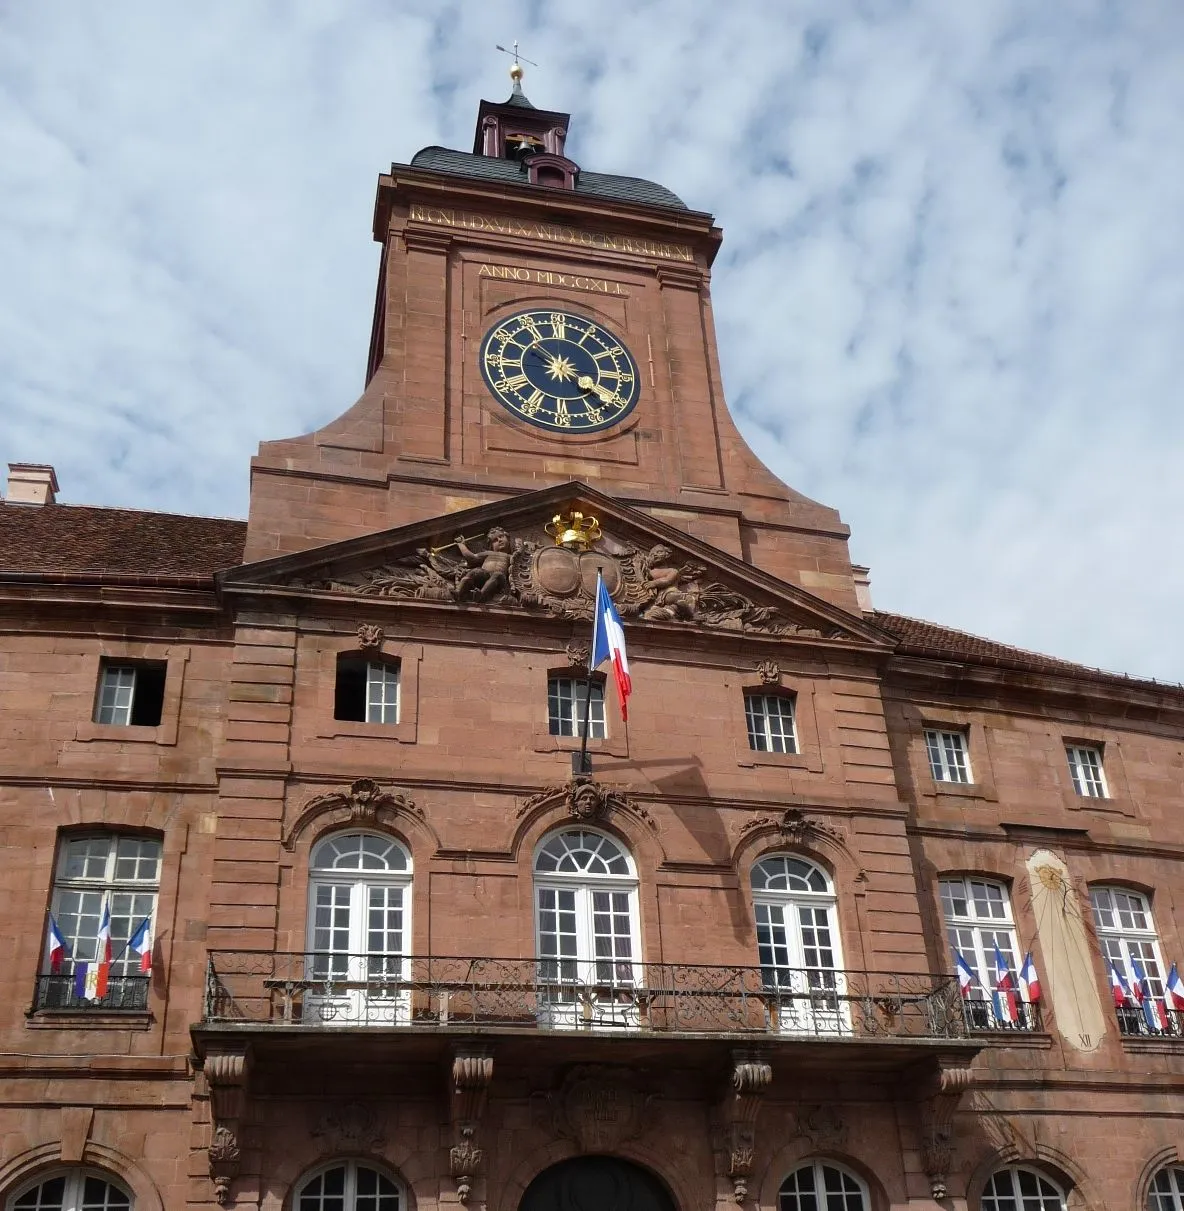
[219,482,893,647]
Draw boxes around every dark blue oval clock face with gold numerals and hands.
[481,311,640,434]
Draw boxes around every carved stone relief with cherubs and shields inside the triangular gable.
[293,526,846,638]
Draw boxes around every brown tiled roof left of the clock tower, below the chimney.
[0,504,247,578]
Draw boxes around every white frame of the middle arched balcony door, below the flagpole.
[533,827,643,1028]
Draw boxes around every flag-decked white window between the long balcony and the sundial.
[941,877,1038,1031]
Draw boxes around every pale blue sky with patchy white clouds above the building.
[0,0,1184,682]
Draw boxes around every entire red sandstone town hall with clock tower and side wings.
[0,73,1184,1211]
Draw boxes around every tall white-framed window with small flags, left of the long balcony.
[34,833,161,1010]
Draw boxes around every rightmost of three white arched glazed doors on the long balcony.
[752,854,851,1034]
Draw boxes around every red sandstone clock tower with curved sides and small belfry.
[246,64,857,612]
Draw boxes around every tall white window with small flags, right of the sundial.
[1090,886,1162,1034]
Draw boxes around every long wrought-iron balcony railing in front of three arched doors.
[205,951,970,1039]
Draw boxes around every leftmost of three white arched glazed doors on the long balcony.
[304,832,412,1026]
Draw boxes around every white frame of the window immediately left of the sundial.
[938,874,1028,1031]
